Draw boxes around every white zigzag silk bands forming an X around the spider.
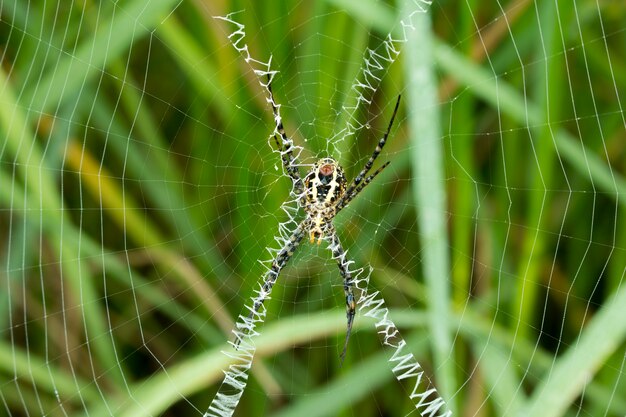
[204,4,452,417]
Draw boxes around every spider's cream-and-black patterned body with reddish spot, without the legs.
[301,158,346,245]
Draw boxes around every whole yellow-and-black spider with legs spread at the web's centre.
[235,79,401,364]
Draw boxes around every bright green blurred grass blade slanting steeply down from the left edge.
[0,69,123,383]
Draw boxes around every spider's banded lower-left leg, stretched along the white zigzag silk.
[234,220,309,349]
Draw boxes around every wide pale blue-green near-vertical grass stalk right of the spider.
[402,0,458,411]
